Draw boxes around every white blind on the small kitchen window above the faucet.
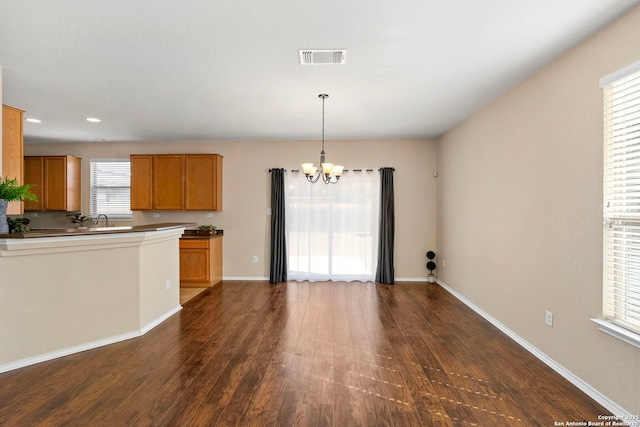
[90,159,133,220]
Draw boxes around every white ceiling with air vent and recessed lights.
[0,0,640,142]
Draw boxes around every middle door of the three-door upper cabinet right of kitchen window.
[153,155,184,210]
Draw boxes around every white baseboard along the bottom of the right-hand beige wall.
[437,279,640,426]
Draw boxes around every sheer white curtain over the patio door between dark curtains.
[285,171,380,281]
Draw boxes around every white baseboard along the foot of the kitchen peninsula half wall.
[0,305,182,373]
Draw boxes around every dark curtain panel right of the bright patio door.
[376,168,395,285]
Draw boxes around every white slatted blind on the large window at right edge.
[603,67,640,333]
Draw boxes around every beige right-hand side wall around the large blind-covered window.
[438,8,640,414]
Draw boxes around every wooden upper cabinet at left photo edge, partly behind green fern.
[2,105,24,215]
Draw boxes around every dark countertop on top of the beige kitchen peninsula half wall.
[0,222,195,239]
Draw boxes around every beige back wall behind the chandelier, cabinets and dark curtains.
[25,139,436,280]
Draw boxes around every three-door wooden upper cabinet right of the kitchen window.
[131,154,222,211]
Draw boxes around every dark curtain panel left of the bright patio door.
[269,169,287,283]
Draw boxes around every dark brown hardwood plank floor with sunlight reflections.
[0,281,607,427]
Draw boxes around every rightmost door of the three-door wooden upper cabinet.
[185,154,222,211]
